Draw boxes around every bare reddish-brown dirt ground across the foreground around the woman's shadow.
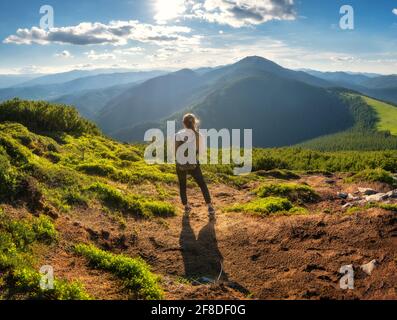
[41,177,397,299]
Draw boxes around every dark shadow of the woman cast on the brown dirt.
[179,215,228,282]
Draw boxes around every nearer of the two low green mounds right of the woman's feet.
[227,197,305,216]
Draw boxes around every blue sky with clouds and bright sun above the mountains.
[0,0,397,74]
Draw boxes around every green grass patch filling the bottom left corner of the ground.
[0,209,90,300]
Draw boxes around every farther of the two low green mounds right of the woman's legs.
[255,183,320,203]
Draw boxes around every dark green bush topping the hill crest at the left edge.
[0,98,100,135]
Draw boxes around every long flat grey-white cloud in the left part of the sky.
[3,20,192,45]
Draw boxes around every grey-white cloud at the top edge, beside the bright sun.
[155,0,296,28]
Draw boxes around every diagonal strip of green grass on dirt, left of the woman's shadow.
[75,244,163,300]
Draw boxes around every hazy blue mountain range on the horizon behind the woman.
[0,56,397,147]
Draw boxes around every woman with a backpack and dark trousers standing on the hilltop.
[175,113,215,215]
